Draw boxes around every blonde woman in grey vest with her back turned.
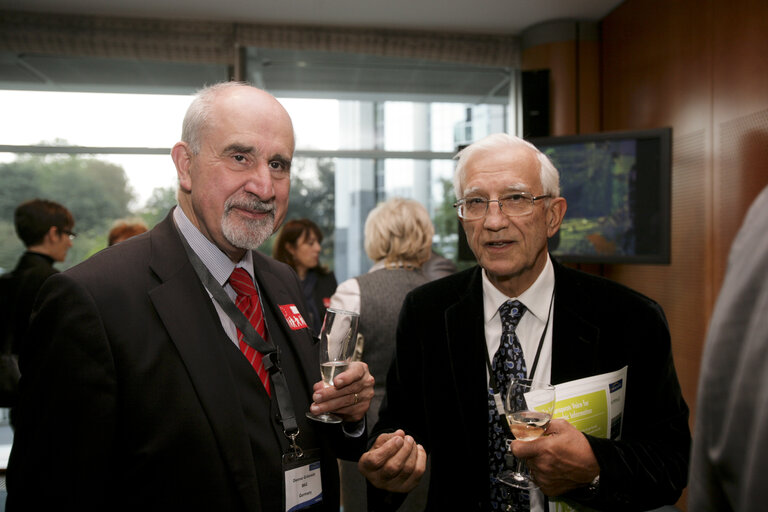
[331,198,434,512]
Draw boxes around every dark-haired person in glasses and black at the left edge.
[0,199,76,425]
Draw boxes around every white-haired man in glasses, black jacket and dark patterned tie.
[358,134,691,511]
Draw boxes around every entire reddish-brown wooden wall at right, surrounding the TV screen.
[601,0,768,510]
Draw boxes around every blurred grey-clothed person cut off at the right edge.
[688,187,768,512]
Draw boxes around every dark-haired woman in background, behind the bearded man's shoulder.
[272,219,336,334]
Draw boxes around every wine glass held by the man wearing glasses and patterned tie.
[497,378,555,489]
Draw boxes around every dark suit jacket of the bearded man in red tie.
[7,210,365,512]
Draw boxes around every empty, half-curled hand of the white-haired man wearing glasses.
[309,361,374,422]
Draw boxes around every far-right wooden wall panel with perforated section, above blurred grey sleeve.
[712,0,768,292]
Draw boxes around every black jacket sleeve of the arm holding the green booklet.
[571,303,691,511]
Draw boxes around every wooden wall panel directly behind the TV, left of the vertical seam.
[601,6,714,470]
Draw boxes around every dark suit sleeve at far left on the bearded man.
[7,274,119,510]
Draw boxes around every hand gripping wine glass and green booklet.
[512,419,600,496]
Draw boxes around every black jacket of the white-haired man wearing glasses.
[369,264,690,511]
